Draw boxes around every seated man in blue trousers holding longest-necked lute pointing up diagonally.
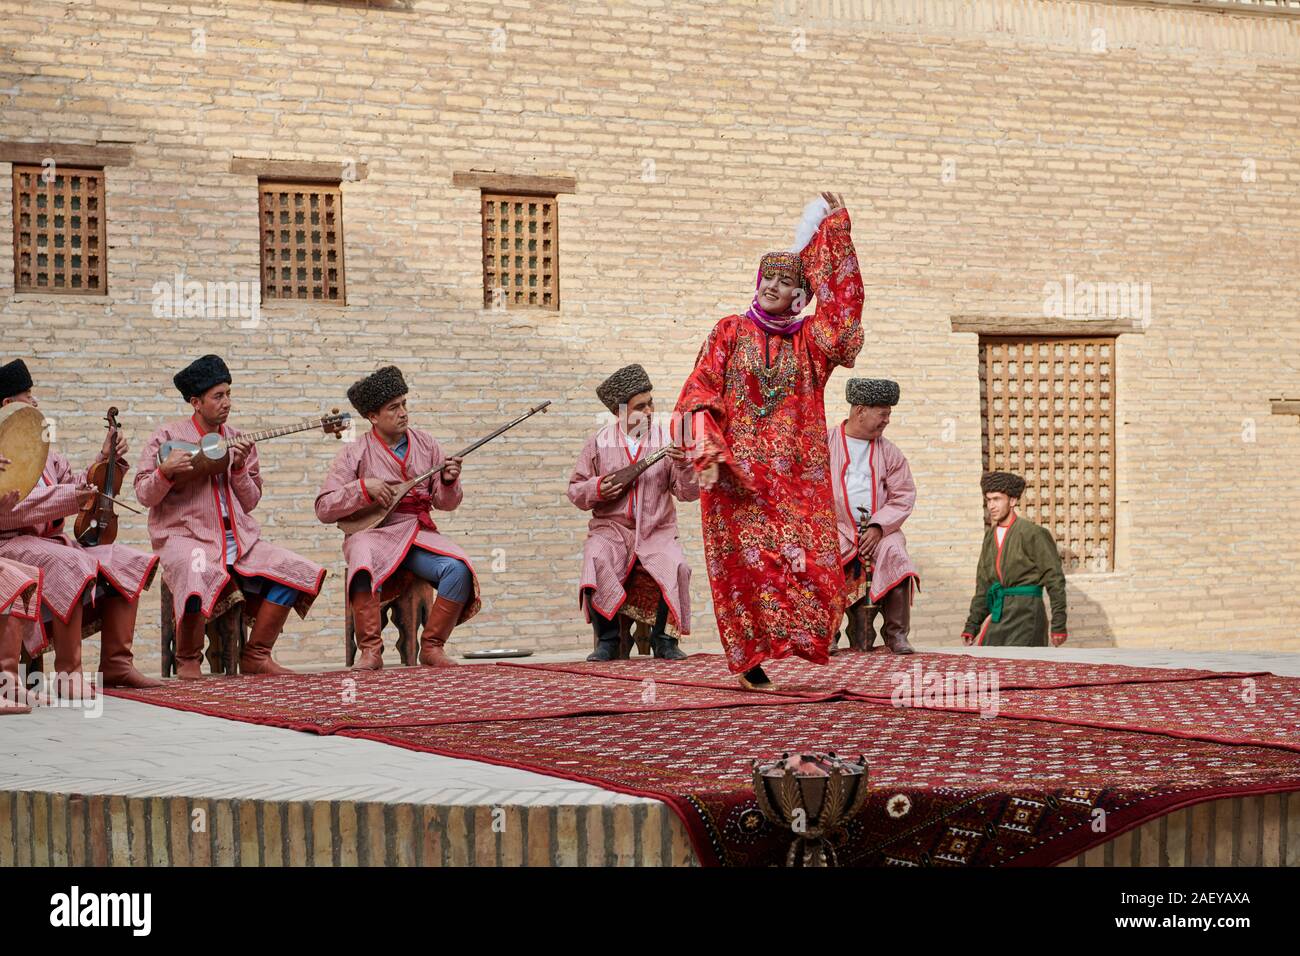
[316,365,481,670]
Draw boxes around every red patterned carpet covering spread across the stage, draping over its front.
[109,653,1300,866]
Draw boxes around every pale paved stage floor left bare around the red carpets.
[0,648,1300,806]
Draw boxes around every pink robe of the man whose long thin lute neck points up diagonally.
[316,428,482,623]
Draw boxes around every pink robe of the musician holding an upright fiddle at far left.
[0,451,157,633]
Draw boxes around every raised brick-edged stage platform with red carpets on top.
[0,648,1300,866]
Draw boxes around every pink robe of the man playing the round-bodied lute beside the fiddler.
[135,416,325,622]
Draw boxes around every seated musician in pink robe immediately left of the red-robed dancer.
[568,365,699,661]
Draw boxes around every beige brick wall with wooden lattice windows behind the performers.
[0,0,1300,665]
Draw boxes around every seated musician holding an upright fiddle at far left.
[0,359,159,698]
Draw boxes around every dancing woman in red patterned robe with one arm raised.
[676,193,863,691]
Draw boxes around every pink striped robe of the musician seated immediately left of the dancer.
[568,421,699,633]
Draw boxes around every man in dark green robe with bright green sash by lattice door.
[962,471,1067,648]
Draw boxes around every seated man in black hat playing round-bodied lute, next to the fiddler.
[135,355,325,680]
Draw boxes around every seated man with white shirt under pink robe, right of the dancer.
[828,378,920,654]
